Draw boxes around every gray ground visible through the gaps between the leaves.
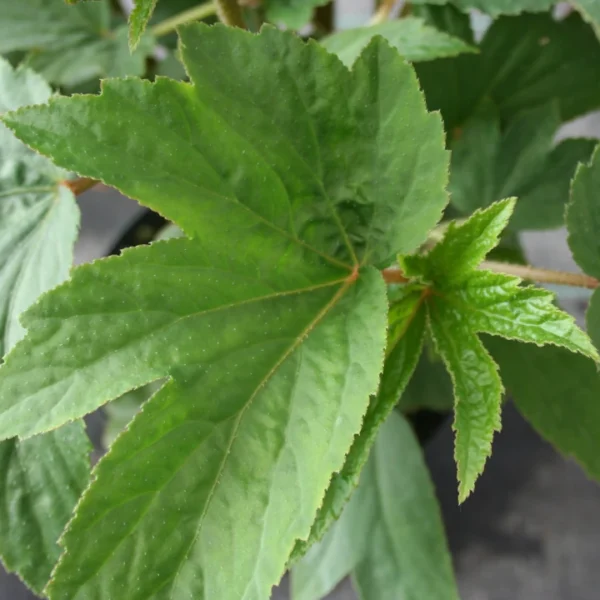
[0,185,600,600]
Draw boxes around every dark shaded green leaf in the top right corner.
[416,13,600,135]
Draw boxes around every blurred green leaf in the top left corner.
[0,0,154,87]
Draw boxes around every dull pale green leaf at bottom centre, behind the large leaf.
[292,412,458,600]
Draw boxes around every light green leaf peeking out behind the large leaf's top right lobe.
[321,17,477,67]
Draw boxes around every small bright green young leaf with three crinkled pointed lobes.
[403,200,598,501]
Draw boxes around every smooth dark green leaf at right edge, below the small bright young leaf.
[485,338,600,479]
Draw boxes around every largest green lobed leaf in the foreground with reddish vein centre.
[0,25,447,600]
